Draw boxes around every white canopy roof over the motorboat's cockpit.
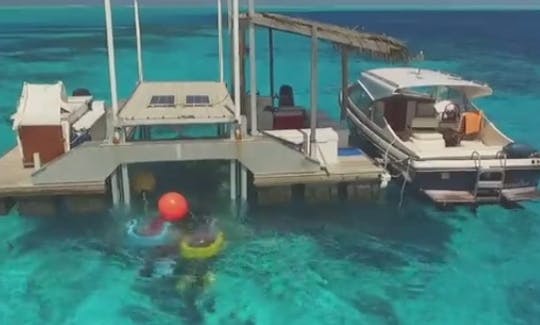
[359,68,493,100]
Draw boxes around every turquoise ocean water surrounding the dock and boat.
[0,8,540,325]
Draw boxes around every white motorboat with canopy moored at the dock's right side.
[340,67,540,204]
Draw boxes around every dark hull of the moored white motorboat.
[350,114,540,203]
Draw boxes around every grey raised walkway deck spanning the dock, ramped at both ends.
[0,132,383,198]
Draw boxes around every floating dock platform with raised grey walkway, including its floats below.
[0,130,384,215]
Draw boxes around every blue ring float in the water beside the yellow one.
[126,219,179,247]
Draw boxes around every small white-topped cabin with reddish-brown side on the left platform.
[11,82,105,168]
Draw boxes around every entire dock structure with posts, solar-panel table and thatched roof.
[0,2,409,215]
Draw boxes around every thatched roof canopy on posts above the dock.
[240,13,410,61]
